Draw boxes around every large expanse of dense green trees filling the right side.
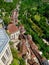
[19,0,49,59]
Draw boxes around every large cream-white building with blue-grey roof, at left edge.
[0,19,13,65]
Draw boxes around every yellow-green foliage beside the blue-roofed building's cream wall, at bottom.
[10,42,26,65]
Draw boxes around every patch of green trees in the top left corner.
[0,0,19,13]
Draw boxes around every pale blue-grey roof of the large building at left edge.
[0,28,9,53]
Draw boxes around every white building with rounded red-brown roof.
[8,24,20,42]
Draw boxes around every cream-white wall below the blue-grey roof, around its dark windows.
[0,44,13,65]
